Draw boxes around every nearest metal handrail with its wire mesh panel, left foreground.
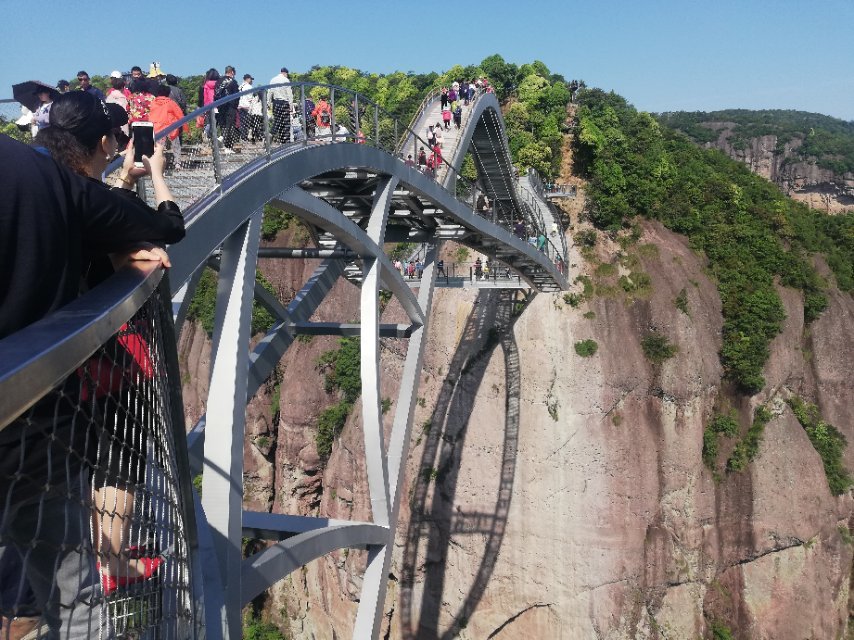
[0,263,203,638]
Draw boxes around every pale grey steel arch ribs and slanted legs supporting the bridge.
[112,82,567,638]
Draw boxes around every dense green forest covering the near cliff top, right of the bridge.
[575,89,854,393]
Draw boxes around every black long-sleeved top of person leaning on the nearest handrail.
[0,134,184,338]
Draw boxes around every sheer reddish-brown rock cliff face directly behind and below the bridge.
[177,223,854,640]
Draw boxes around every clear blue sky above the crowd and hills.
[0,0,854,120]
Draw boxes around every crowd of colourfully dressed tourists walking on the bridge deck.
[13,62,492,177]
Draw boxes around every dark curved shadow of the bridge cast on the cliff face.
[401,290,530,640]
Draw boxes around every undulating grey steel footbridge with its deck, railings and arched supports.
[8,83,568,638]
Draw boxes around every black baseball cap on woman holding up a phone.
[49,91,128,148]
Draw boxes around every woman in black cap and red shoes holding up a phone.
[37,91,180,595]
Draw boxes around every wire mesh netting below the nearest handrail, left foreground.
[0,289,194,640]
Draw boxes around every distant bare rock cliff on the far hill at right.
[705,122,854,213]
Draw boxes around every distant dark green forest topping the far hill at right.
[657,109,854,174]
